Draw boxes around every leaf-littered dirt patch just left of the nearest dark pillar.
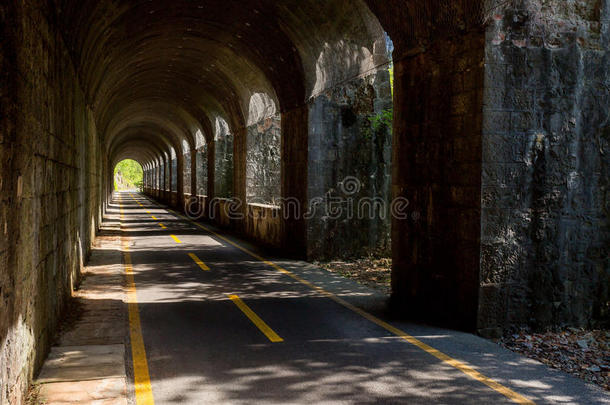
[314,256,392,294]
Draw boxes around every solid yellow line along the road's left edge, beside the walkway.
[119,196,155,405]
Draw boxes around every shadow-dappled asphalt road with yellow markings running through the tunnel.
[111,193,610,404]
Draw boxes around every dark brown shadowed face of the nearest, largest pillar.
[391,30,485,331]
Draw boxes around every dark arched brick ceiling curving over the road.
[56,0,387,164]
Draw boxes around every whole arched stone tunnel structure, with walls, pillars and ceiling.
[0,0,610,404]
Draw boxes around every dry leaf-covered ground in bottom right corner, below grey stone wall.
[498,328,610,391]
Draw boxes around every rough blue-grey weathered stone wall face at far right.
[478,0,610,334]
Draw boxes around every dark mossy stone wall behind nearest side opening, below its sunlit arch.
[307,67,392,258]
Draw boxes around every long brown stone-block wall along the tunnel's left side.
[0,1,103,404]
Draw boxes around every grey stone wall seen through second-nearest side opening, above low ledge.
[246,114,282,204]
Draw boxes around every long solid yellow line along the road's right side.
[167,209,534,405]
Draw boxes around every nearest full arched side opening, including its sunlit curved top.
[307,30,393,261]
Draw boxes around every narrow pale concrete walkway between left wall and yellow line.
[35,221,128,405]
